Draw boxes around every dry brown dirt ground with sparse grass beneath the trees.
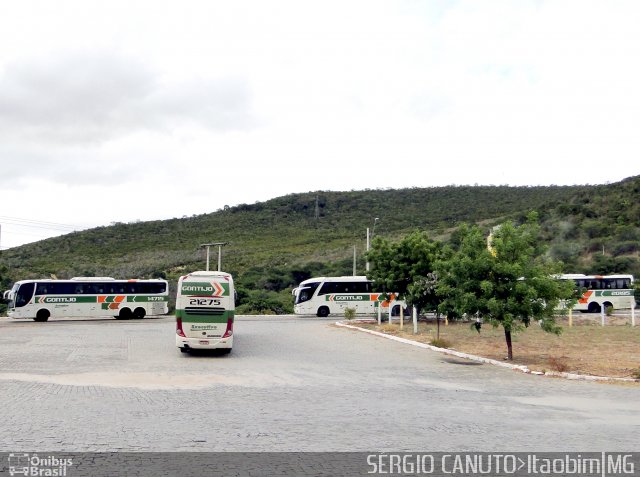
[352,313,640,378]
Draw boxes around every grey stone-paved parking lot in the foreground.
[0,317,640,452]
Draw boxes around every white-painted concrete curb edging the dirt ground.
[336,321,640,383]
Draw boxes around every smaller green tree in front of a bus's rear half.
[367,232,441,308]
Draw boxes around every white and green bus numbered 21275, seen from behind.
[176,271,236,353]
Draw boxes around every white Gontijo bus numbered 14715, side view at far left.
[7,277,169,321]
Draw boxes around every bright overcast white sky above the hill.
[0,0,640,249]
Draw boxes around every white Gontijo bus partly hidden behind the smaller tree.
[291,276,406,317]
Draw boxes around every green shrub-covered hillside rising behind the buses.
[0,177,640,313]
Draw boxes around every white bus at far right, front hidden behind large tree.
[560,273,636,313]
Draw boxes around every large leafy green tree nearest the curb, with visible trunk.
[436,213,573,360]
